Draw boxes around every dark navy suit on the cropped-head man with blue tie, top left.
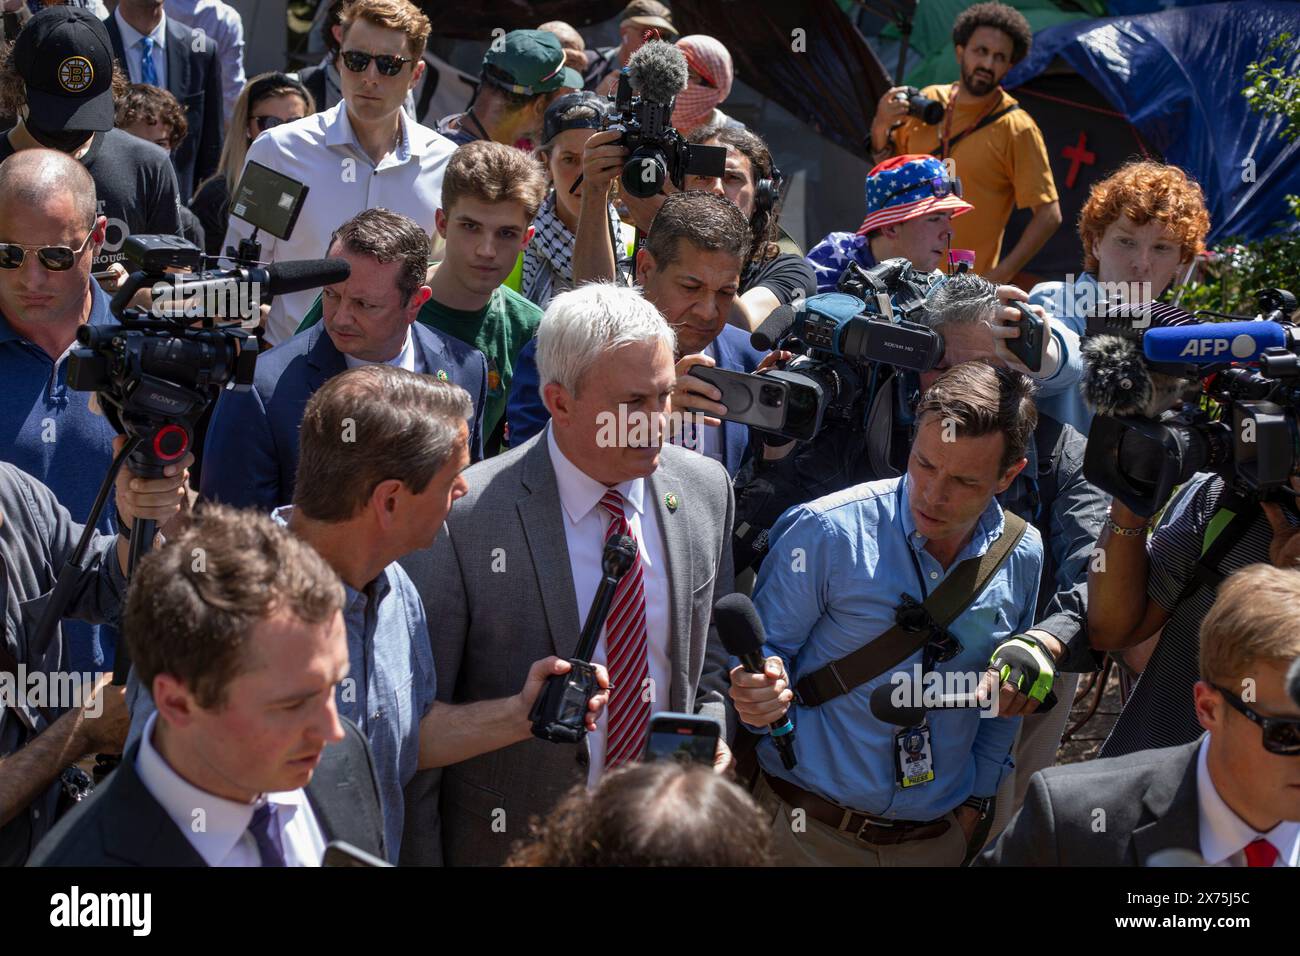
[104,17,220,204]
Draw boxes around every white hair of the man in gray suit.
[537,282,677,394]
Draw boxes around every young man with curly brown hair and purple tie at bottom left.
[31,507,384,866]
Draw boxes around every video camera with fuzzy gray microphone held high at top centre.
[601,40,727,199]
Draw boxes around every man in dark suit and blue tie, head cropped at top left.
[104,0,225,202]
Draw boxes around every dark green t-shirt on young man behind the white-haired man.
[298,286,542,455]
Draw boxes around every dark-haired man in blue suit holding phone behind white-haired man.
[508,191,763,477]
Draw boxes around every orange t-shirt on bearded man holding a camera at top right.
[893,83,1057,272]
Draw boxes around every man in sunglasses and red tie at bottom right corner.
[976,564,1300,866]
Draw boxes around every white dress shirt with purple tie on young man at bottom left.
[135,713,325,866]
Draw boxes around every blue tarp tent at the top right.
[1004,0,1300,242]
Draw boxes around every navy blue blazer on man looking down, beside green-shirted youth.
[199,323,488,511]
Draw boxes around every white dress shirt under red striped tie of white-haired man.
[546,425,672,787]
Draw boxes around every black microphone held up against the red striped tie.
[528,535,637,744]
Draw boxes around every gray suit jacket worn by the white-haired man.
[402,431,733,865]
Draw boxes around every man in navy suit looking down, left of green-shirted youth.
[200,209,488,511]
